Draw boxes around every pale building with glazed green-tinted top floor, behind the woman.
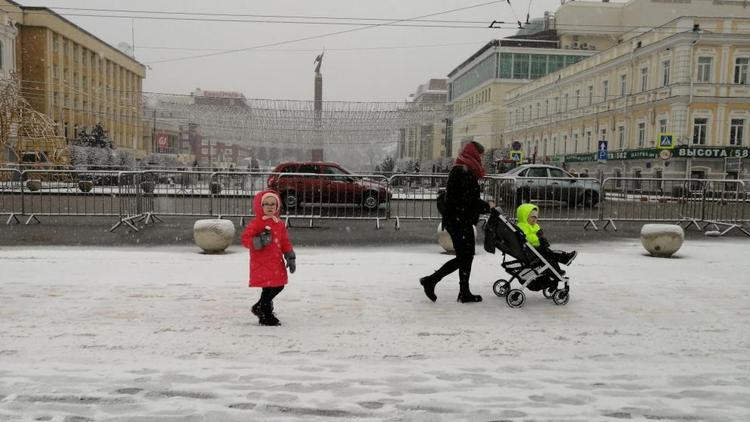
[448,19,595,163]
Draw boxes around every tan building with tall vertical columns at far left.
[0,0,148,157]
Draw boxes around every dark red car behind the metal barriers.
[268,162,391,209]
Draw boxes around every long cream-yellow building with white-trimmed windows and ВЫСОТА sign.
[504,0,750,178]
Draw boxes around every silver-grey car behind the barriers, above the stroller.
[496,164,602,207]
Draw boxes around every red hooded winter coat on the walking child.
[242,190,292,287]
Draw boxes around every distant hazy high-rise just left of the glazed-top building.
[398,79,448,166]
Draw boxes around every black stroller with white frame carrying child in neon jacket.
[483,209,570,308]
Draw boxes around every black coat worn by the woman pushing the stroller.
[443,166,490,227]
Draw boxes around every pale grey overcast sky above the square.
[16,0,624,101]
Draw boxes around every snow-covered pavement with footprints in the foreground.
[0,239,750,421]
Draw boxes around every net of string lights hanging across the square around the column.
[144,94,451,167]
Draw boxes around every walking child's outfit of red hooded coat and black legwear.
[242,190,296,322]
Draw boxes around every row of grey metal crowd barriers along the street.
[0,169,750,236]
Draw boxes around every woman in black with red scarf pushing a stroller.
[419,142,495,303]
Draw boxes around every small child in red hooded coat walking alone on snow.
[242,190,297,325]
